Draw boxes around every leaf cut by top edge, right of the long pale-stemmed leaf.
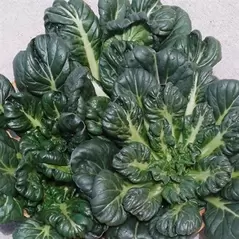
[98,0,130,26]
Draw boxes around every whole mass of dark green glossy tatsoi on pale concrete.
[0,0,239,239]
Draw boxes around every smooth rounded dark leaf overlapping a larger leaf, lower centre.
[90,170,127,226]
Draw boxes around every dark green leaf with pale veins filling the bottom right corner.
[204,197,239,239]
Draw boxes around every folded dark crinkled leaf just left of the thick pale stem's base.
[64,67,95,120]
